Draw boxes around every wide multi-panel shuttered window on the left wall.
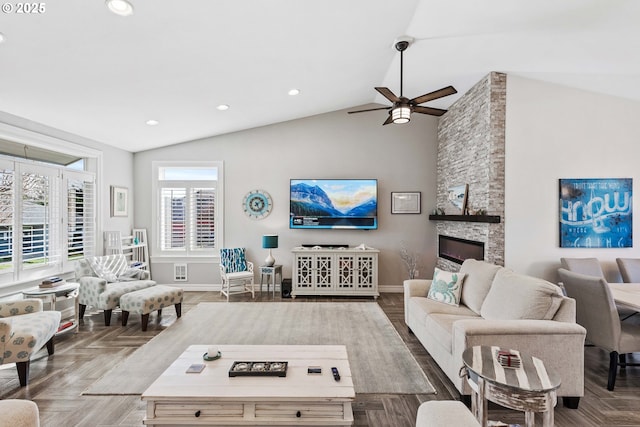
[0,157,96,287]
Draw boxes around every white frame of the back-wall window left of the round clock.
[151,160,224,262]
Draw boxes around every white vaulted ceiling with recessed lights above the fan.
[0,0,640,152]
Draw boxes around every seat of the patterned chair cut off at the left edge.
[0,311,60,363]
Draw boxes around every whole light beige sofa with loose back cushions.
[404,259,586,408]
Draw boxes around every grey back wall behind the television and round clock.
[134,105,437,286]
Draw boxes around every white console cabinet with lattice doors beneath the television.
[291,248,380,298]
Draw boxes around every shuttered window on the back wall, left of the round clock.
[154,162,222,256]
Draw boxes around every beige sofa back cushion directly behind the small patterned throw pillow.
[460,259,503,314]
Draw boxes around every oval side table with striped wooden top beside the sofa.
[462,346,560,427]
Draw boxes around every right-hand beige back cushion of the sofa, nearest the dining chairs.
[480,268,562,320]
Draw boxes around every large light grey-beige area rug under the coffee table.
[83,302,435,395]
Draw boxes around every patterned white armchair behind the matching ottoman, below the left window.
[75,254,156,326]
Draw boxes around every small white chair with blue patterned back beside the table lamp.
[220,248,255,301]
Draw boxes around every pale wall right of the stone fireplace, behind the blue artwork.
[505,75,640,281]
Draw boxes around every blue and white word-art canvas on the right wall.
[560,178,633,248]
